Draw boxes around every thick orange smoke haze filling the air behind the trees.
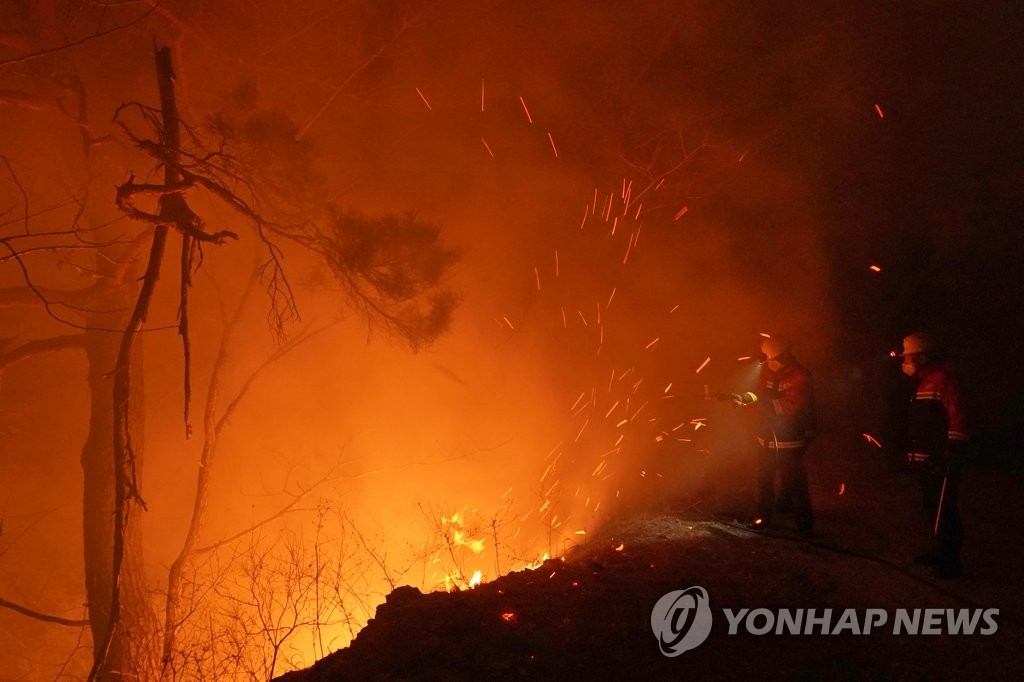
[0,1,1020,678]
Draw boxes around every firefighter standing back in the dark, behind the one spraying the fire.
[898,332,968,578]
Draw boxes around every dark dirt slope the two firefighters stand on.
[282,434,1024,682]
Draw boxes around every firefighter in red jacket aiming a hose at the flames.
[736,336,816,538]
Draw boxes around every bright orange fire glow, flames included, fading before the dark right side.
[0,2,863,679]
